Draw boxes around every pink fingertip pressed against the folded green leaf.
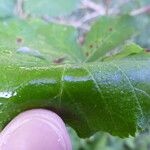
[0,109,72,150]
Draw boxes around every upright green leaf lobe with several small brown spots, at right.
[84,16,136,61]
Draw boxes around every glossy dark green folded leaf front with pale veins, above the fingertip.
[0,60,150,137]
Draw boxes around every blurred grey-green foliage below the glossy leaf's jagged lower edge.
[68,128,150,150]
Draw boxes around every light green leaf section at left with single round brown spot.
[0,20,83,64]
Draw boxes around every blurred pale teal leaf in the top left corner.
[0,0,15,18]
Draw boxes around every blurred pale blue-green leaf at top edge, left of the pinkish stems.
[24,0,80,16]
